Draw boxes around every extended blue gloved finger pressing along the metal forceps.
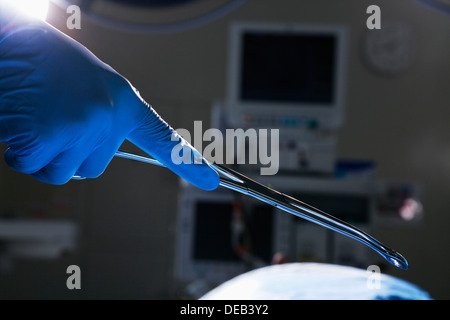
[128,107,220,190]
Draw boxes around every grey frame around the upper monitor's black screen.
[226,22,348,129]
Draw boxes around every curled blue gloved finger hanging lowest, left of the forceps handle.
[31,145,86,185]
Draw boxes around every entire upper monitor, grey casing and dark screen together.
[225,22,347,130]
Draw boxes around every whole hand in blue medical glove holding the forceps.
[0,2,219,190]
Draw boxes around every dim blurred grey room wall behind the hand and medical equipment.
[0,0,450,299]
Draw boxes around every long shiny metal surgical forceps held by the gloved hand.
[89,151,408,270]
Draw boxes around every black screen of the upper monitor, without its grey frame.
[240,31,336,107]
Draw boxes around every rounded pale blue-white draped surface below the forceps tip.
[200,263,431,300]
